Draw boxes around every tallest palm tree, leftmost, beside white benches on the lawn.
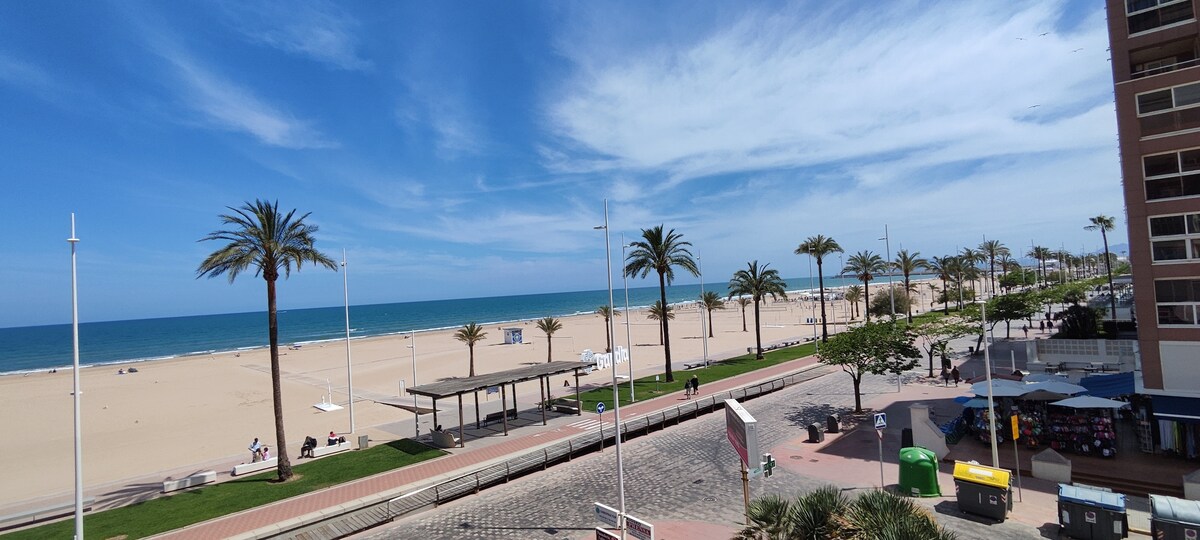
[196,200,337,481]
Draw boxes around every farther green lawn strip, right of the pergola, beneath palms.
[580,343,816,414]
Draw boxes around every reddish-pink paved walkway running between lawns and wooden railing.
[156,356,816,539]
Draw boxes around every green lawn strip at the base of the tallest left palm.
[4,439,444,540]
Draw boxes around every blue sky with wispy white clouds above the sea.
[0,0,1126,326]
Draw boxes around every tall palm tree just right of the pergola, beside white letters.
[625,224,700,383]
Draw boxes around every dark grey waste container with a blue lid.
[1058,484,1129,540]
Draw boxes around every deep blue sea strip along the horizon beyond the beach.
[0,277,858,374]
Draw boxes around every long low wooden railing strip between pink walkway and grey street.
[273,365,827,539]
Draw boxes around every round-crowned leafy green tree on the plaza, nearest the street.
[817,320,920,413]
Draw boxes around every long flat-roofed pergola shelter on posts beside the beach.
[406,361,595,448]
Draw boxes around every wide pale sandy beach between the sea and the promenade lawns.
[0,283,929,514]
